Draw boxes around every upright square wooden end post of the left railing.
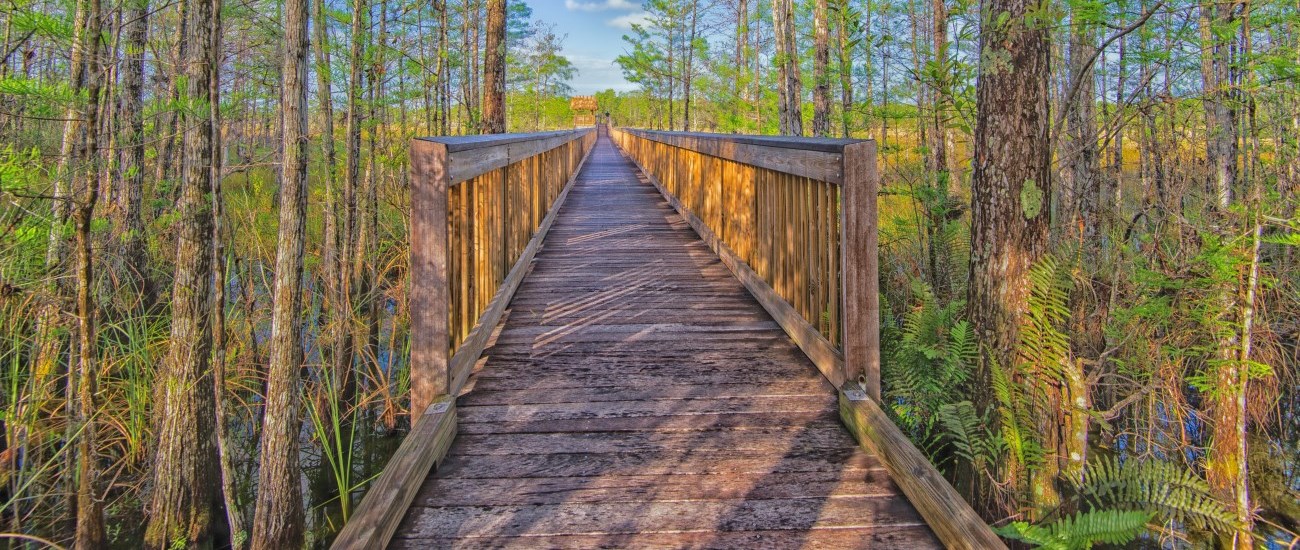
[411,139,451,426]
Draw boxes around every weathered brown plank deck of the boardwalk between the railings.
[391,137,939,549]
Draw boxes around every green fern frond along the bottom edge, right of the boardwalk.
[995,510,1153,550]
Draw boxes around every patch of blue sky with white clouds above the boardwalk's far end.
[527,0,645,95]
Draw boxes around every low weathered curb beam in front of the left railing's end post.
[332,397,456,550]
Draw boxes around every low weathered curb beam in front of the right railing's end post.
[840,391,1006,550]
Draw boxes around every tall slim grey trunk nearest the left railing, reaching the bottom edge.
[251,0,308,550]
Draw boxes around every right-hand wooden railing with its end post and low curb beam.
[610,129,1005,549]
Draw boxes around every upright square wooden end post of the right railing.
[840,140,880,402]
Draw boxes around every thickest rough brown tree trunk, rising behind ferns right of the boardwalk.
[967,0,1052,517]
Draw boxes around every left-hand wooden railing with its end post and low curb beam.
[334,127,597,549]
